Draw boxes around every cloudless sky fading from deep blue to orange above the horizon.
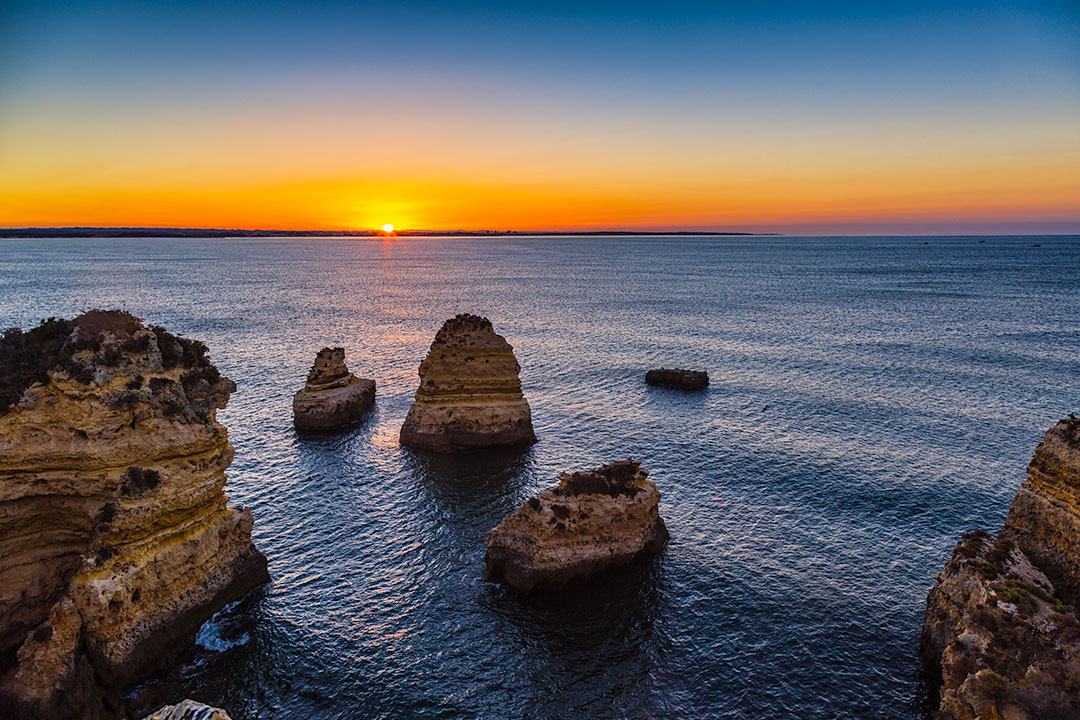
[0,0,1080,234]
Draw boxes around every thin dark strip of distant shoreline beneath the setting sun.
[0,228,764,237]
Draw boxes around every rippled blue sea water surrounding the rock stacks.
[0,236,1080,720]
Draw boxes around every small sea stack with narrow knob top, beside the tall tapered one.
[293,348,375,431]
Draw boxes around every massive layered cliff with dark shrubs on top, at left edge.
[0,311,269,720]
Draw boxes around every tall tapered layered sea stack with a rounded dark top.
[401,314,537,451]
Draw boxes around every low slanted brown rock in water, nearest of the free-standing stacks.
[484,460,667,593]
